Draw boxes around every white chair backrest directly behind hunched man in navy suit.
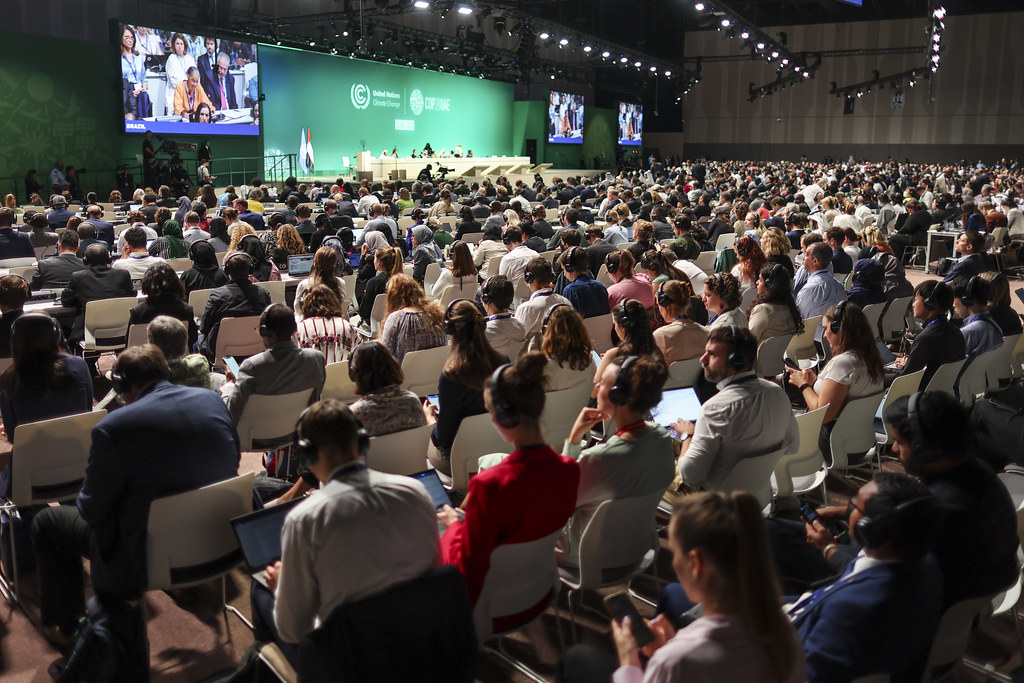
[145,472,254,590]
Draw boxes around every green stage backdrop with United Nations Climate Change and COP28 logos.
[260,45,513,176]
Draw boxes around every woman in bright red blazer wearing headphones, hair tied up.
[437,353,580,606]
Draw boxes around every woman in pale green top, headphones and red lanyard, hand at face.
[556,355,676,566]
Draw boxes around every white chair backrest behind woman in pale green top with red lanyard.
[572,490,665,589]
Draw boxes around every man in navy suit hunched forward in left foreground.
[32,344,240,643]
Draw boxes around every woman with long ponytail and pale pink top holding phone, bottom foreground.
[559,493,807,683]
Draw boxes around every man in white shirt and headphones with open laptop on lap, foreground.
[250,398,439,664]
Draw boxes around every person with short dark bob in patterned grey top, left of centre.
[348,342,426,436]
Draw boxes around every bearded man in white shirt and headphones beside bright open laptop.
[673,326,800,489]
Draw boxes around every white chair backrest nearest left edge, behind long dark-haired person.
[10,411,106,507]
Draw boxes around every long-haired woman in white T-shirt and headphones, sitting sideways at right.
[790,302,885,463]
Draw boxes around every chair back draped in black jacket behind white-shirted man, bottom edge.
[297,565,477,683]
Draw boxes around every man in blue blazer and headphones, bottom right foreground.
[787,473,942,683]
